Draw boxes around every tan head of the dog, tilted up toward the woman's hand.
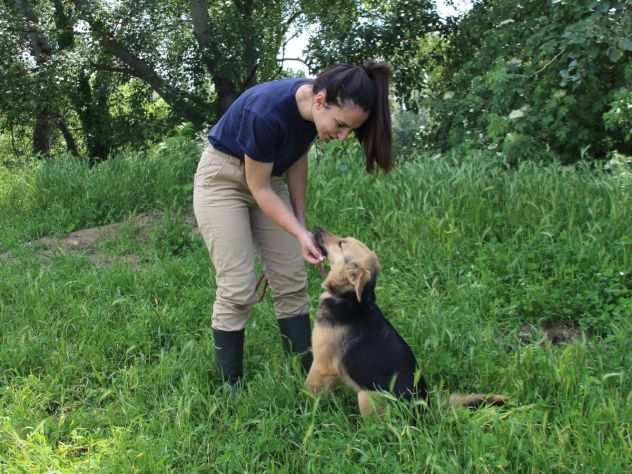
[314,228,380,302]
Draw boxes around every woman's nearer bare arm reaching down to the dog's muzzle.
[245,155,321,264]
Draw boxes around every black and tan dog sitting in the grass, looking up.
[305,229,506,416]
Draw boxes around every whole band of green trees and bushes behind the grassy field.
[0,0,632,164]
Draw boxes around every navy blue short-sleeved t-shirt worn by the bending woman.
[208,79,316,176]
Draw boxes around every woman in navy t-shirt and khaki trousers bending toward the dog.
[193,63,392,388]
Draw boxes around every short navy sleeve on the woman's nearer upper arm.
[237,109,281,163]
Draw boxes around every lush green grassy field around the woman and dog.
[0,139,632,474]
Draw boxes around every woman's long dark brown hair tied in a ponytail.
[313,62,393,173]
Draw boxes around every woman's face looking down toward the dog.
[312,91,369,140]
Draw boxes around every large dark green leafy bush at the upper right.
[429,0,632,162]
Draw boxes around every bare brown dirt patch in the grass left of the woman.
[0,211,198,267]
